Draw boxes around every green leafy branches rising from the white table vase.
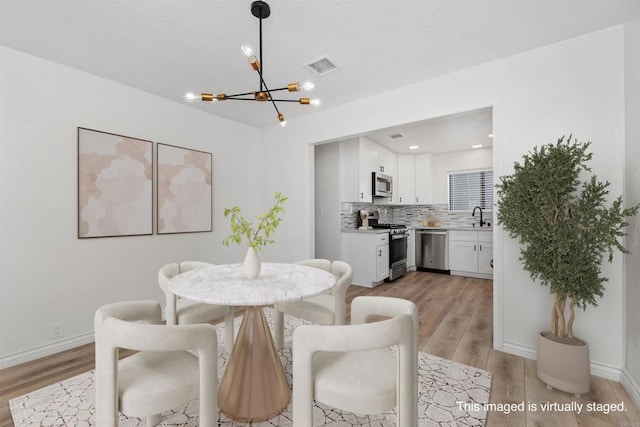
[222,192,288,250]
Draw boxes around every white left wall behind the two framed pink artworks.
[0,46,260,368]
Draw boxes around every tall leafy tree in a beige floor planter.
[497,136,638,396]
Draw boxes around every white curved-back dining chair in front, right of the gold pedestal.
[293,296,418,427]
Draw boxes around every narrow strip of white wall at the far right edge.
[622,1,640,406]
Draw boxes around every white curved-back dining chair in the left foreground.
[94,301,218,427]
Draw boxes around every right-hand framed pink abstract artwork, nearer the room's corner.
[156,144,212,234]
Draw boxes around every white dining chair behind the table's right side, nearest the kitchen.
[273,259,353,349]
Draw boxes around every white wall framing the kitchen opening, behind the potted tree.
[262,26,625,378]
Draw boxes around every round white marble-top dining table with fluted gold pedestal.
[169,263,336,423]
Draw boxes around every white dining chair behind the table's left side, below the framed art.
[158,261,234,353]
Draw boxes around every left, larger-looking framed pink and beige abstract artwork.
[78,127,153,239]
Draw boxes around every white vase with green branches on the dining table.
[222,192,287,279]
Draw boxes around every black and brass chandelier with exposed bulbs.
[184,1,320,126]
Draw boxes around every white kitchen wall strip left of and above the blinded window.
[431,148,493,205]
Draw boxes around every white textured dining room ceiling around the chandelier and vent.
[0,0,640,133]
